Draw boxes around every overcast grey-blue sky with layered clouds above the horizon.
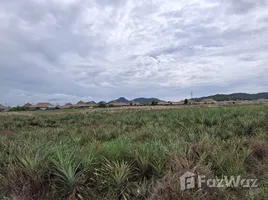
[0,0,268,105]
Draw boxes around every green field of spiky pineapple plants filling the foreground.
[0,105,268,200]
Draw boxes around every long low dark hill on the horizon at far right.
[192,92,268,101]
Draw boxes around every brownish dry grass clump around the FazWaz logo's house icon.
[148,157,227,200]
